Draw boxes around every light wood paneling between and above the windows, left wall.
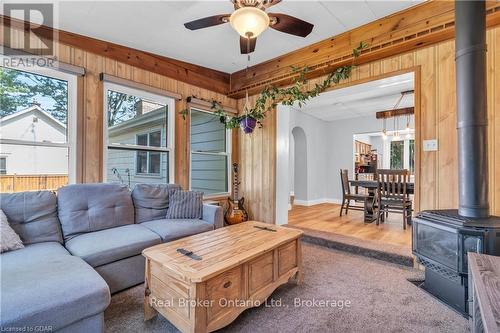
[0,22,238,188]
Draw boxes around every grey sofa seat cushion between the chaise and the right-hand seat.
[66,224,161,267]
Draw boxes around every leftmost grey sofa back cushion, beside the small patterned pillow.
[0,191,63,245]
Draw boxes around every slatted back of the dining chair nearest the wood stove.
[377,169,410,200]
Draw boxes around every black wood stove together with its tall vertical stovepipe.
[412,0,500,315]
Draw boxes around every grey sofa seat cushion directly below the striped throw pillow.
[141,219,214,242]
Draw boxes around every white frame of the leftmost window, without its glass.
[0,63,78,184]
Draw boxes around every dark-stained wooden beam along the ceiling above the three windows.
[0,15,230,94]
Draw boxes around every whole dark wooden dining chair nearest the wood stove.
[376,169,412,230]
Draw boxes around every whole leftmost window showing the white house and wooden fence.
[0,66,76,192]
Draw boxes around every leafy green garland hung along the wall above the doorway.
[181,42,367,129]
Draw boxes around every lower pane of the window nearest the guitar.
[191,153,228,195]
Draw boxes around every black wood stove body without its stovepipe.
[413,210,500,314]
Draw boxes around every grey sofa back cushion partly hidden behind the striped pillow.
[132,184,181,223]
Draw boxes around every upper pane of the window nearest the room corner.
[191,110,226,152]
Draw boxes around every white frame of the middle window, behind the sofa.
[103,82,175,184]
